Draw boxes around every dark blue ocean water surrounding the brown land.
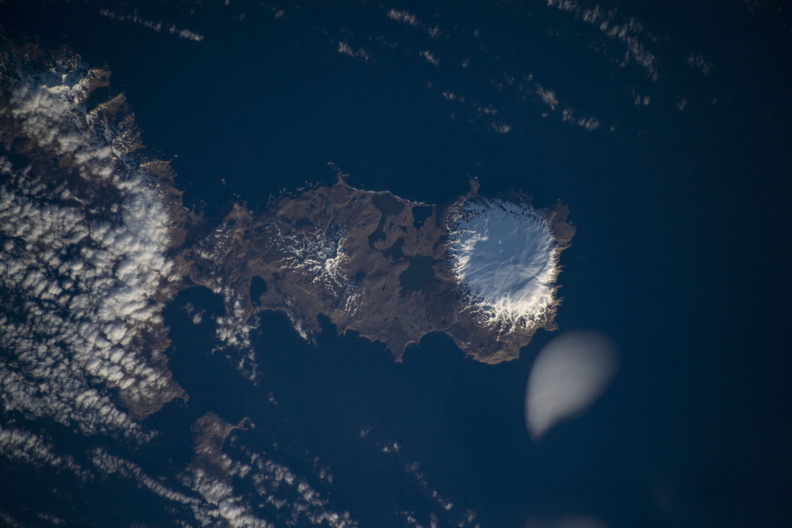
[3,1,792,528]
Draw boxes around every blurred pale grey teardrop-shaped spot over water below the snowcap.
[525,331,617,439]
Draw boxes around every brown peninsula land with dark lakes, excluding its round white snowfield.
[176,177,575,363]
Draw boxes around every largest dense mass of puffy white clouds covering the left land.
[0,49,181,441]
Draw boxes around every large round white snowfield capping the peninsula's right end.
[449,199,559,327]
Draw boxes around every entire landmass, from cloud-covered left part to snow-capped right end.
[0,39,575,443]
